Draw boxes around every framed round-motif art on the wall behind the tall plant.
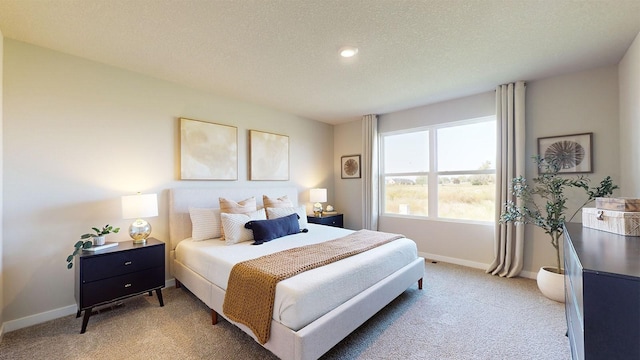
[538,133,593,174]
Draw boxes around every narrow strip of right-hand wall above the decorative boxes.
[618,33,640,198]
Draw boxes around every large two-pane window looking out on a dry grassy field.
[380,116,496,221]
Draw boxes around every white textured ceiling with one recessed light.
[0,0,640,124]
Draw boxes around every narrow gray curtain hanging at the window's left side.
[360,115,379,230]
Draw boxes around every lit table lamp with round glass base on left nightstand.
[122,193,158,244]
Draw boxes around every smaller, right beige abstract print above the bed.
[249,130,289,180]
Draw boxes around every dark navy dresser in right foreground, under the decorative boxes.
[564,223,640,360]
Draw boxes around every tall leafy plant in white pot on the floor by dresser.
[500,156,618,302]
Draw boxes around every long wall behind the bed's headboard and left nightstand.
[2,39,335,331]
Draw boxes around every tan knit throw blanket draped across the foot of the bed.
[222,230,403,344]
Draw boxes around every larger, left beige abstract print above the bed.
[180,118,238,180]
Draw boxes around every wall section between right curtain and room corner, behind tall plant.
[524,65,622,272]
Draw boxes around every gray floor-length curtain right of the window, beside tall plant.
[487,81,526,277]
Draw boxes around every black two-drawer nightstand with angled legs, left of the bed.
[75,238,165,334]
